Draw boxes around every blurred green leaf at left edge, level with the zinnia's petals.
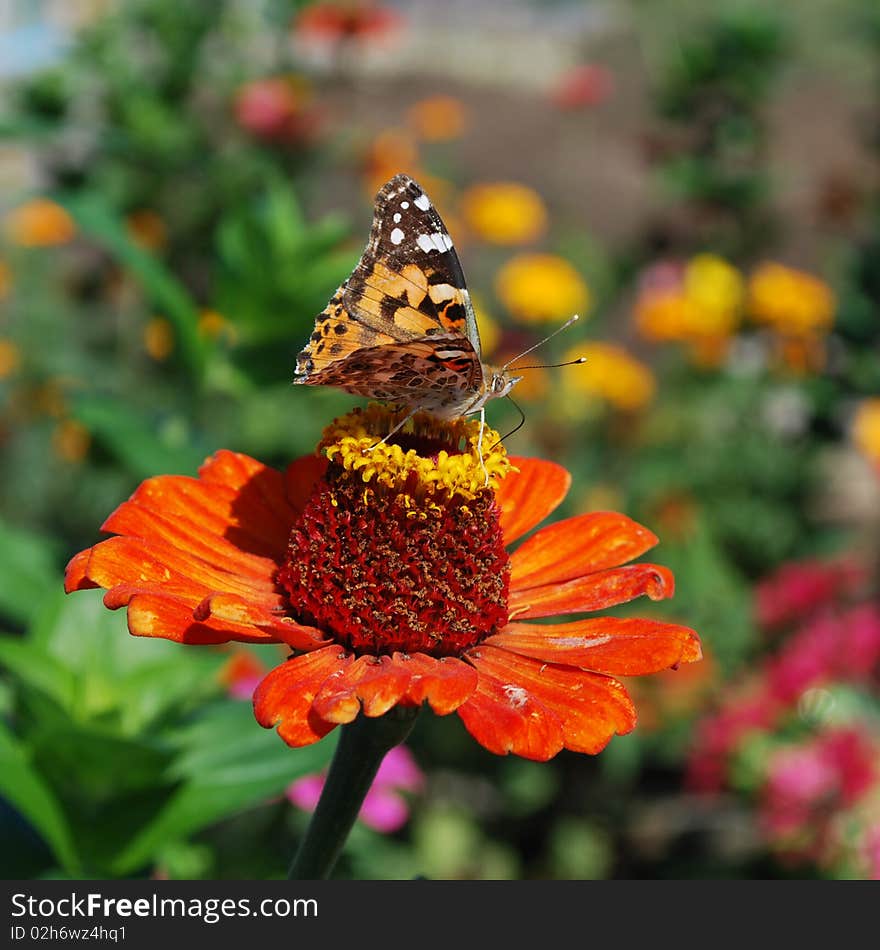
[0,521,58,623]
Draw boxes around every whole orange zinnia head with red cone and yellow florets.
[66,406,700,760]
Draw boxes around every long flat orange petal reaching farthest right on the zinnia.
[485,617,702,676]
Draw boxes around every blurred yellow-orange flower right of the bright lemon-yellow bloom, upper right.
[748,261,836,336]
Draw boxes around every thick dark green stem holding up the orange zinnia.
[287,706,419,881]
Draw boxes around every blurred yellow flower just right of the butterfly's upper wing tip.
[461,181,547,244]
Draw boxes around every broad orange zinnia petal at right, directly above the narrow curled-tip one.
[510,511,657,589]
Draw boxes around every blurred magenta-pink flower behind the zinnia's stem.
[287,746,425,834]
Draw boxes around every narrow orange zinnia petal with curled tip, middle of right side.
[508,564,675,620]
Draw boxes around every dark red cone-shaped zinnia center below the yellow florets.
[278,445,510,657]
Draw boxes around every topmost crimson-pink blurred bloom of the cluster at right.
[755,558,865,628]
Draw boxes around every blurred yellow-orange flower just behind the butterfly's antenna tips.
[561,343,656,411]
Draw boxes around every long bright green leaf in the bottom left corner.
[0,723,81,877]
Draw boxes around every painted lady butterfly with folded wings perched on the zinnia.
[294,174,522,419]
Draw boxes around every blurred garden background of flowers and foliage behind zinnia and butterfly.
[0,0,880,879]
